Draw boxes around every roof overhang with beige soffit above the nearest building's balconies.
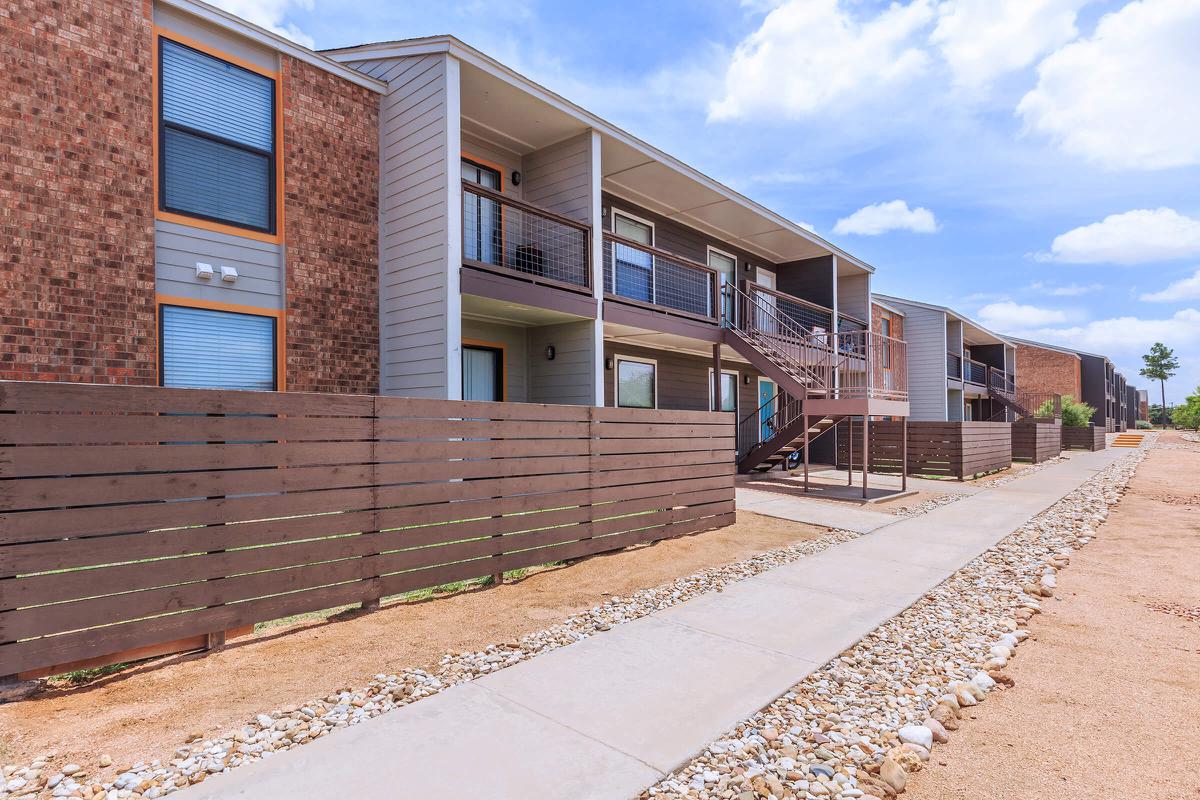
[323,36,875,272]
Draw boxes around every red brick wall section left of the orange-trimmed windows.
[0,0,157,384]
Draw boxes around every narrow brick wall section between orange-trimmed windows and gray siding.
[283,56,379,393]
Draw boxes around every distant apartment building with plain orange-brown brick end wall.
[1010,337,1138,433]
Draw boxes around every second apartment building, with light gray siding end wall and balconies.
[874,295,1021,422]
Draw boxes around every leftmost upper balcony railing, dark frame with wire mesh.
[462,181,592,290]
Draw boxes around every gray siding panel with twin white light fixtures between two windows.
[155,219,283,309]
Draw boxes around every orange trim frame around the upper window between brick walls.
[150,25,283,245]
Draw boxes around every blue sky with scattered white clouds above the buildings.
[218,0,1200,402]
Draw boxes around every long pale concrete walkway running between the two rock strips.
[184,450,1124,800]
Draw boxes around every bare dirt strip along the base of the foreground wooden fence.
[0,512,823,769]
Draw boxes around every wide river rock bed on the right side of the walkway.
[642,450,1145,800]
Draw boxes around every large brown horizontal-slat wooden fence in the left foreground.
[0,383,734,676]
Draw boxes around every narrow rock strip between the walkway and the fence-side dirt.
[0,530,860,800]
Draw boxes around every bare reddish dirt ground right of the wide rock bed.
[905,432,1200,800]
